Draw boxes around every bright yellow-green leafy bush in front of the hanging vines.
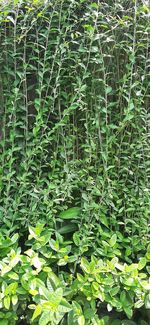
[0,224,150,325]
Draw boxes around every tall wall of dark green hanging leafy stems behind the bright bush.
[0,0,150,325]
